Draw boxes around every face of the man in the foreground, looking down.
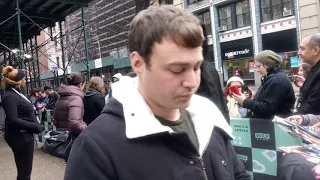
[138,39,203,119]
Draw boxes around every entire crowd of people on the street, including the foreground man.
[2,5,320,180]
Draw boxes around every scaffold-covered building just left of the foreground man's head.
[66,0,149,77]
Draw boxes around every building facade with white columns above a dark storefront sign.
[184,0,304,85]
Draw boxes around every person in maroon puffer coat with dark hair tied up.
[53,73,87,136]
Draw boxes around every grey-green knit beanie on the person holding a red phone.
[254,50,282,66]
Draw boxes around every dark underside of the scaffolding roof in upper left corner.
[0,0,91,50]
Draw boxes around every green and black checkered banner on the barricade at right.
[230,118,302,180]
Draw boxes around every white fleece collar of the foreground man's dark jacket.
[109,77,233,154]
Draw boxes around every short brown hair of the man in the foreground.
[128,5,203,65]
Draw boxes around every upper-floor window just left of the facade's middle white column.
[236,1,251,28]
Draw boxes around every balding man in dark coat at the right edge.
[297,33,320,115]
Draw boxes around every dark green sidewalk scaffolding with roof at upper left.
[0,0,90,93]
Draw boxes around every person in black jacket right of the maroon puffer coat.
[83,76,105,125]
